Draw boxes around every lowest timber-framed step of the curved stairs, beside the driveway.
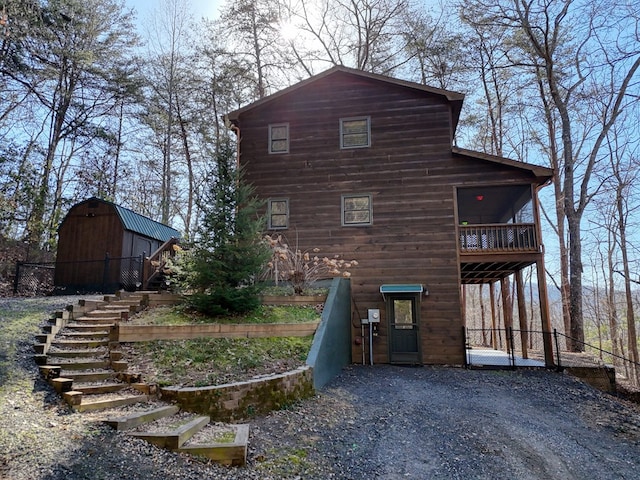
[178,424,249,467]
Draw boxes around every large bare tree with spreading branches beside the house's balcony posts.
[460,0,640,351]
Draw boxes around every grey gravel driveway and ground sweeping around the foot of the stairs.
[0,298,640,480]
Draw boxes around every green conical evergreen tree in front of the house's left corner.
[189,144,270,316]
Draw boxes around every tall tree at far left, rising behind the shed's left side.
[0,0,141,255]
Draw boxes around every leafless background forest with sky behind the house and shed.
[5,0,640,376]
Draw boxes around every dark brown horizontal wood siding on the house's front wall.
[238,74,544,364]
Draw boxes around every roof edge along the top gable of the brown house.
[226,65,464,130]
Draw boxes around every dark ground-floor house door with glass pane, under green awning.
[387,295,422,364]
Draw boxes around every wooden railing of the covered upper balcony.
[458,223,540,253]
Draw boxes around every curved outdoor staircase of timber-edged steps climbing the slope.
[34,292,249,465]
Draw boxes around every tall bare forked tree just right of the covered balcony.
[465,0,640,350]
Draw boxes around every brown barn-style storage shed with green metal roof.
[54,197,180,292]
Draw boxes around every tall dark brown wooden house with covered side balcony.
[227,67,552,364]
